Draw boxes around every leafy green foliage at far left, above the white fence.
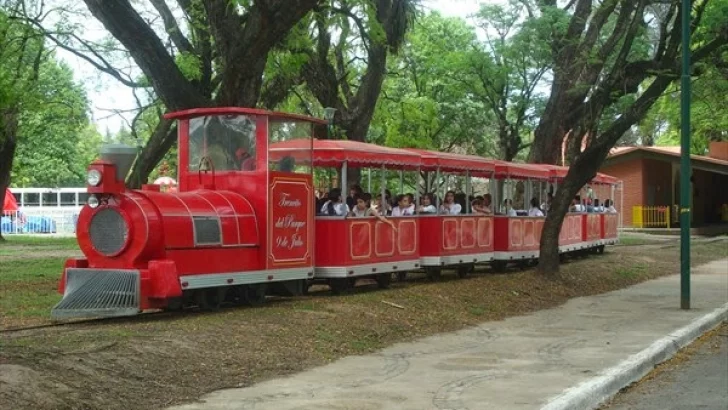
[0,2,100,186]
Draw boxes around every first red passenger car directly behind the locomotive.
[271,140,421,293]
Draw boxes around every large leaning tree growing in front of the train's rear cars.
[529,0,728,273]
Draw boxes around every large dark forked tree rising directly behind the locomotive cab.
[24,0,322,185]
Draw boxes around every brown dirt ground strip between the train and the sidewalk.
[0,240,728,410]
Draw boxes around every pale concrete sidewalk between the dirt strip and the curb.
[175,260,728,410]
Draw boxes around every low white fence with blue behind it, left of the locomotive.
[0,207,80,235]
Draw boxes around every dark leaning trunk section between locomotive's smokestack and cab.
[126,118,177,189]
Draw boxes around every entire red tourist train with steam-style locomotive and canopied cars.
[51,108,619,318]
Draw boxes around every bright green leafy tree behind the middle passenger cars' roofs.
[369,12,490,156]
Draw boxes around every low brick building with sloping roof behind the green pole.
[600,142,728,227]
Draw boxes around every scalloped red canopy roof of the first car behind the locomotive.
[269,139,422,169]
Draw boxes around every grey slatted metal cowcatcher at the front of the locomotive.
[51,268,142,319]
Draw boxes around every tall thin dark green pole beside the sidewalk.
[680,0,692,309]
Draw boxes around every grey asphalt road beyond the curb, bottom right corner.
[602,324,728,410]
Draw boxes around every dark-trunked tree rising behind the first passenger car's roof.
[299,0,417,151]
